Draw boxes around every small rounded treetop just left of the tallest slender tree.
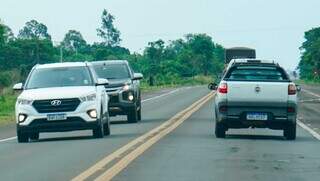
[62,30,87,54]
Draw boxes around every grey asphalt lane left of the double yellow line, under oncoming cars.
[0,87,209,181]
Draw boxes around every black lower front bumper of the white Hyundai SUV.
[17,117,98,133]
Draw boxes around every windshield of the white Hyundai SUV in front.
[26,67,93,89]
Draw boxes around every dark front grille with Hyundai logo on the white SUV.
[32,98,81,113]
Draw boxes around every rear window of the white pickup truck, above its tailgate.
[225,66,288,81]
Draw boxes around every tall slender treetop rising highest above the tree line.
[97,9,121,47]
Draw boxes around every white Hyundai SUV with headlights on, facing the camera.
[14,62,110,142]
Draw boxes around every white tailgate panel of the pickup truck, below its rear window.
[227,81,288,106]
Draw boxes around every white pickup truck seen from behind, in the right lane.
[209,59,297,140]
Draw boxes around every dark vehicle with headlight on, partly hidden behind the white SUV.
[92,60,143,123]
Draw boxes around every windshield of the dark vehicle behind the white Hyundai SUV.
[94,64,130,79]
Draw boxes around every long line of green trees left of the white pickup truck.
[0,10,224,90]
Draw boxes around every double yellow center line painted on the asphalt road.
[72,93,214,181]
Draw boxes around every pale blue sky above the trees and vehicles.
[0,0,320,70]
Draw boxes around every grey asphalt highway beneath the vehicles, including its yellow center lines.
[0,85,320,181]
